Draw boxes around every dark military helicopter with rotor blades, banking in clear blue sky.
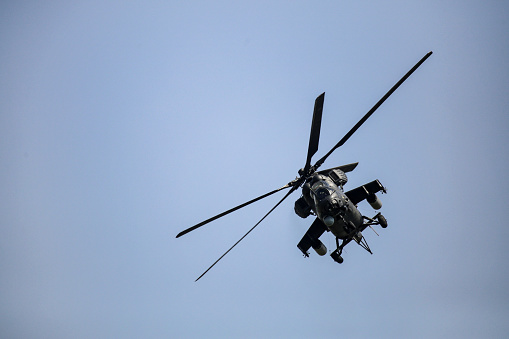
[177,52,433,281]
